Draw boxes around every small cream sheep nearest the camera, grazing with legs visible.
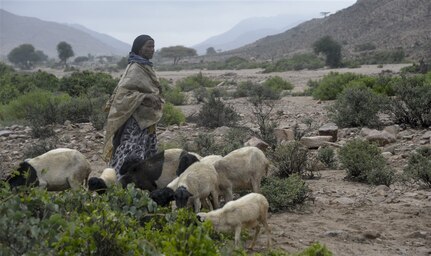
[197,193,271,249]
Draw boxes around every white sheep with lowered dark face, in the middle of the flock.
[174,162,219,212]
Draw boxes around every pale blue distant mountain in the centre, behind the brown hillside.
[192,15,307,54]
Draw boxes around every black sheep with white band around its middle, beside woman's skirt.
[119,148,198,192]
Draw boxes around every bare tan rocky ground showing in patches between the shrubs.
[0,65,431,256]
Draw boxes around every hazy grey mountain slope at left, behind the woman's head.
[0,9,130,57]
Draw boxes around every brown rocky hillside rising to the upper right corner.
[218,0,431,59]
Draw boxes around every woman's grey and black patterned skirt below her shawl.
[109,117,157,179]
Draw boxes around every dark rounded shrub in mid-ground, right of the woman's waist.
[197,96,239,128]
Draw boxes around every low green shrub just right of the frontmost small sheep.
[261,174,311,212]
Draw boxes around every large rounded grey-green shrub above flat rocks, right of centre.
[328,87,385,127]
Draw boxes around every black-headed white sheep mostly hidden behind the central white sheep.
[150,155,222,206]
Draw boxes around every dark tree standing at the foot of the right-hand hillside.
[313,36,341,68]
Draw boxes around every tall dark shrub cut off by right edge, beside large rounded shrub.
[391,75,431,128]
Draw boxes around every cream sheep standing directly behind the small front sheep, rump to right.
[214,146,270,202]
